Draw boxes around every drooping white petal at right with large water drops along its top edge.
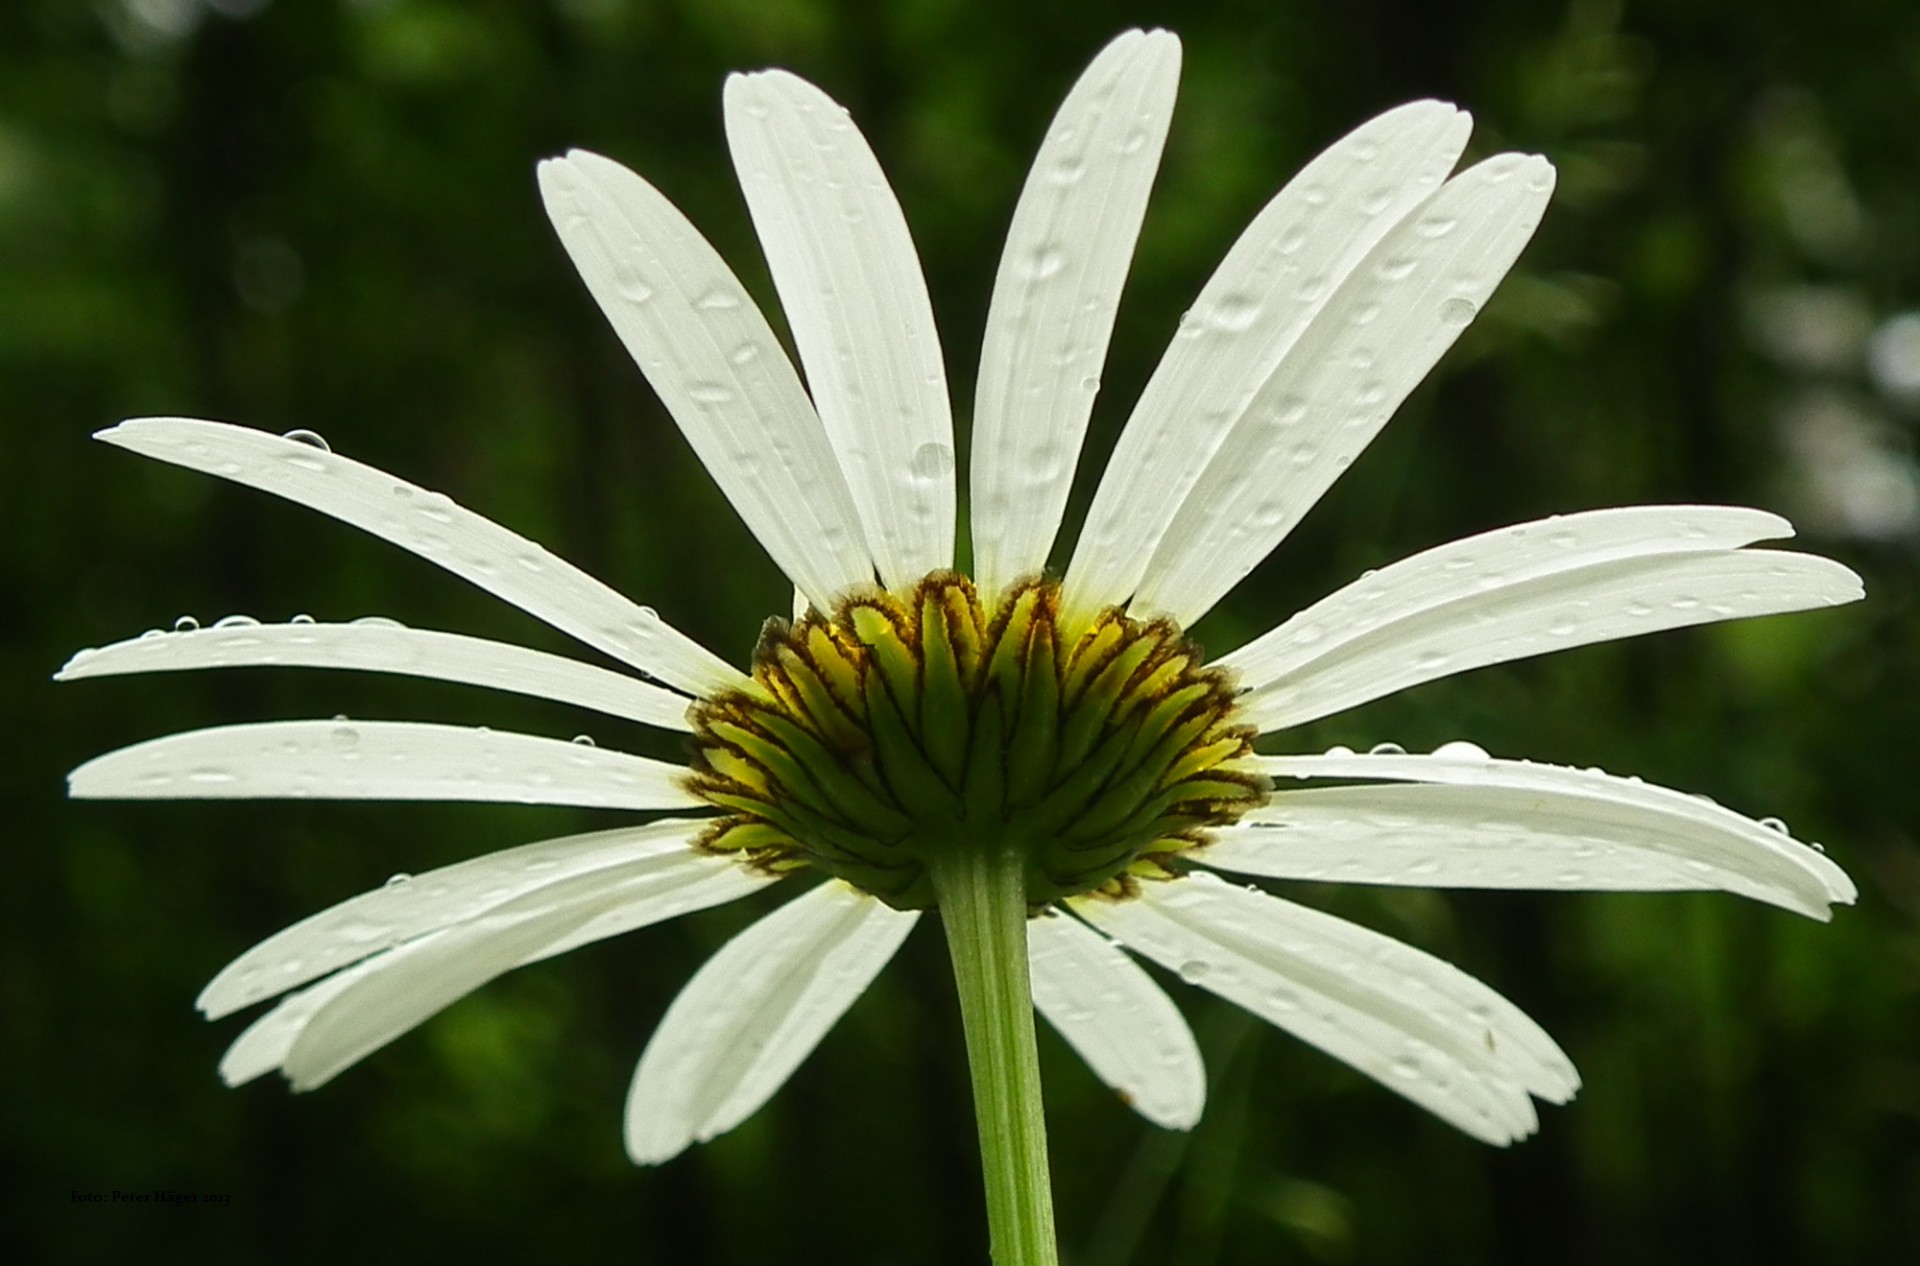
[1244,745,1857,920]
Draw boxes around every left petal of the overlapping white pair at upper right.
[1066,102,1471,615]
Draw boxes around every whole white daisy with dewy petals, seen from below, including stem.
[60,31,1860,1260]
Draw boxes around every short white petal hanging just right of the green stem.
[1027,914,1206,1130]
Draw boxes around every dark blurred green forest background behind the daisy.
[0,0,1920,1266]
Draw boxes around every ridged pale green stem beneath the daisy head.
[927,847,1060,1266]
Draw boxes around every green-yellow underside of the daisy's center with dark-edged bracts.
[689,571,1269,909]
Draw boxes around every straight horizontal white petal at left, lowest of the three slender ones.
[67,720,705,809]
